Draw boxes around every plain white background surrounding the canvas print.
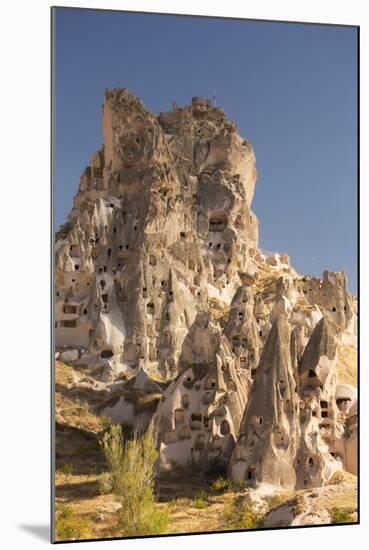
[0,0,369,550]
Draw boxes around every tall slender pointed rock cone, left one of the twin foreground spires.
[230,316,300,487]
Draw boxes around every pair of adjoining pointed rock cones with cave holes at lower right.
[230,316,357,489]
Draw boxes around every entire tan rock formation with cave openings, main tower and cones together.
[55,89,356,485]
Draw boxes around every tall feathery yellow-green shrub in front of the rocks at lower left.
[101,425,168,535]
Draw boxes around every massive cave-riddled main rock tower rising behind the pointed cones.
[56,89,257,384]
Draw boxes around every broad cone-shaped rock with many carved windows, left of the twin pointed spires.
[155,316,251,470]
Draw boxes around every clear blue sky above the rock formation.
[55,8,357,291]
